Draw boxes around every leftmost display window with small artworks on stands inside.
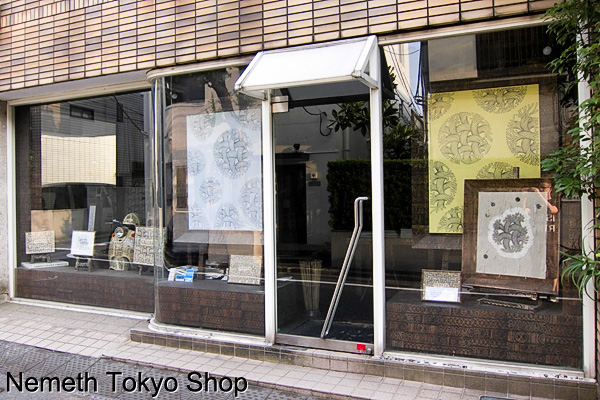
[16,93,153,312]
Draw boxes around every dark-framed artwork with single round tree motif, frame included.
[462,179,560,295]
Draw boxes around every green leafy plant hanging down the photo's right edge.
[542,0,600,296]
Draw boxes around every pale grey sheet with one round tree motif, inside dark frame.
[477,191,548,279]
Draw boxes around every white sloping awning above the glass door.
[235,36,379,102]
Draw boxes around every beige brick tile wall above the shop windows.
[0,0,553,91]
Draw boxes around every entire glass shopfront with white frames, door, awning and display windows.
[2,0,595,388]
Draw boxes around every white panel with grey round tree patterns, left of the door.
[186,109,262,231]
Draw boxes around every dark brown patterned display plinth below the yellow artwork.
[386,292,583,368]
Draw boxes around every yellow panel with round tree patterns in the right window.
[428,85,540,233]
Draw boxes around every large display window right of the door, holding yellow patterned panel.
[383,27,582,368]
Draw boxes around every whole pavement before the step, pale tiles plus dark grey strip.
[0,303,548,400]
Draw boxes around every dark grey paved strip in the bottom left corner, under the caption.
[0,341,317,400]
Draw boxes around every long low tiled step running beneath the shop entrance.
[130,329,596,400]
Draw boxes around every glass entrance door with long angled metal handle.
[273,103,373,353]
